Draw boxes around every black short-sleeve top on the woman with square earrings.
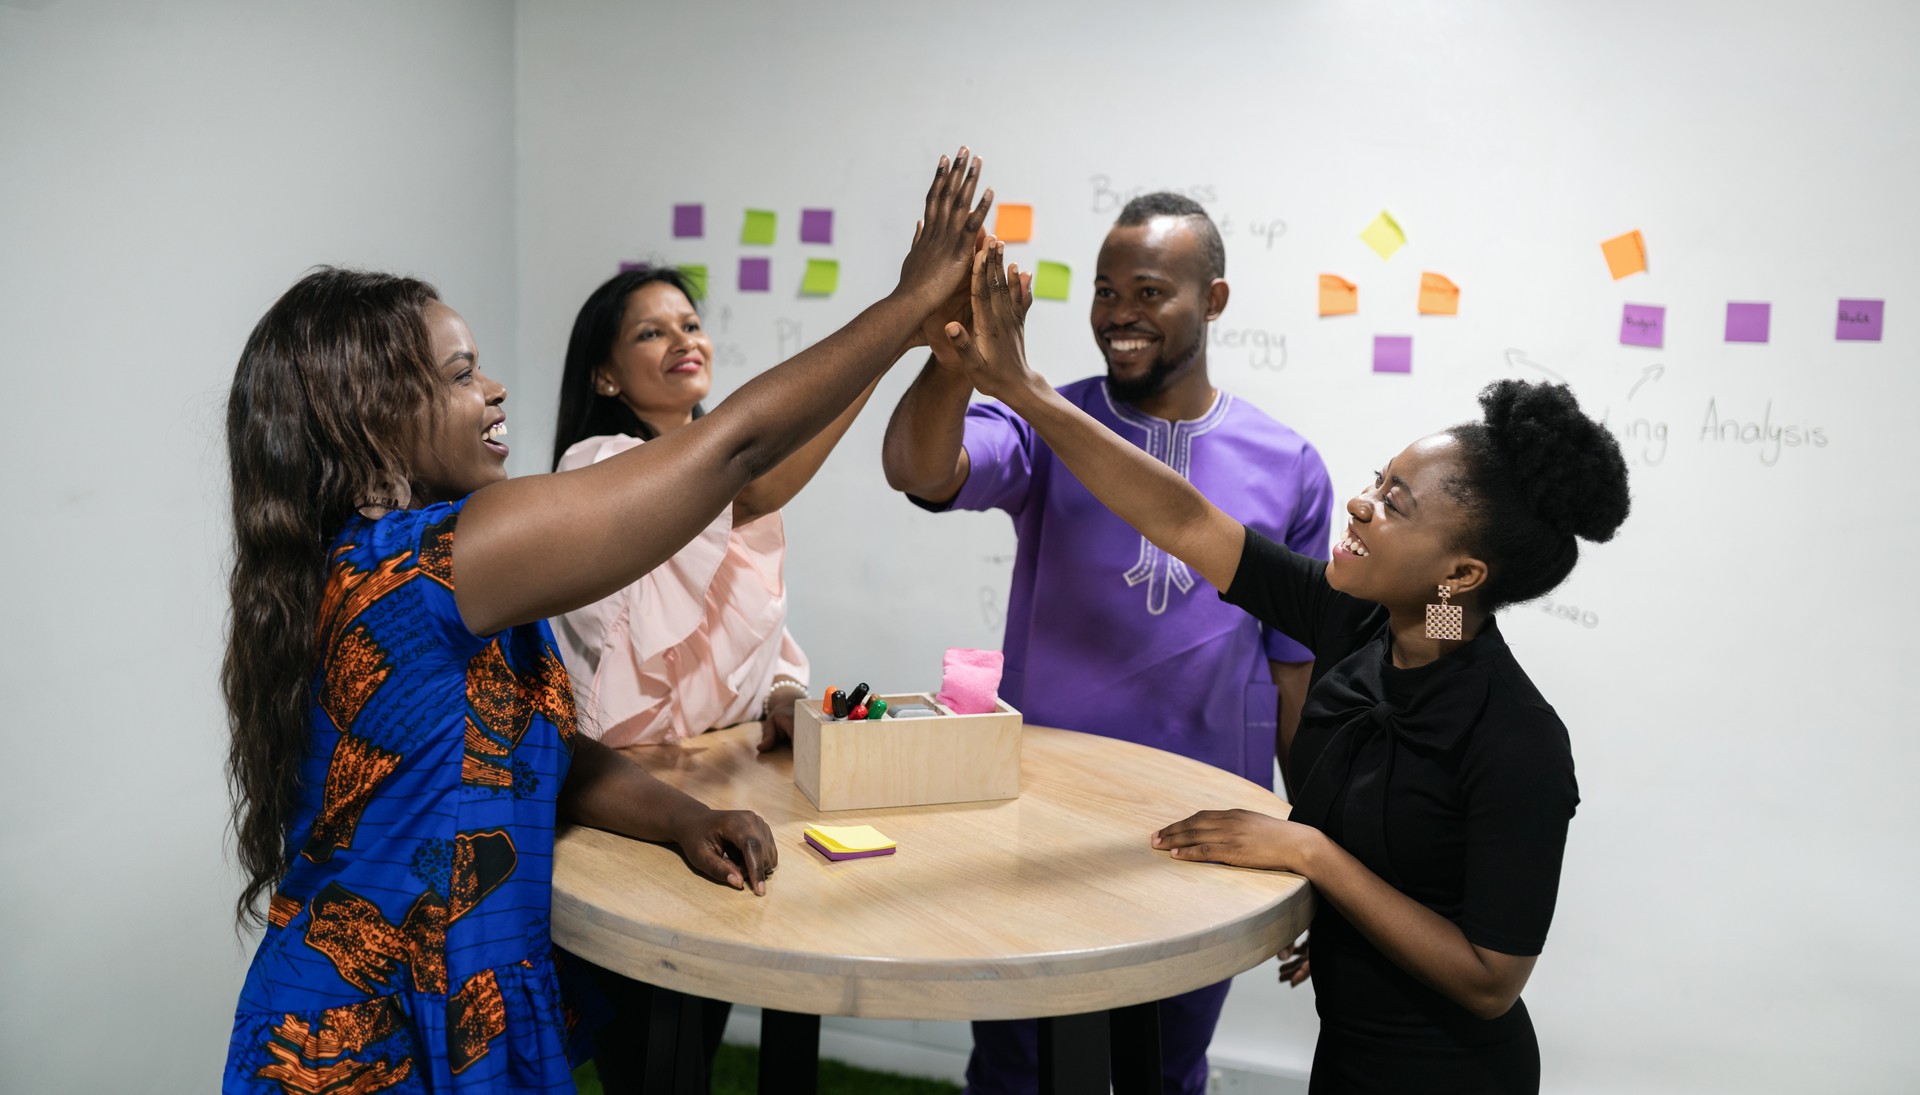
[1221,528,1580,1043]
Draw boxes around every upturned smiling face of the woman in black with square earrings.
[1327,434,1486,613]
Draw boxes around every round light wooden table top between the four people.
[553,724,1311,1091]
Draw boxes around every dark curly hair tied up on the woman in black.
[1446,380,1630,613]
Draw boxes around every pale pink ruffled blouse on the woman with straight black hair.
[553,436,806,747]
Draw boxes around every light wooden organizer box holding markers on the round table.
[793,692,1025,811]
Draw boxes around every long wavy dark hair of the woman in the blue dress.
[221,267,440,924]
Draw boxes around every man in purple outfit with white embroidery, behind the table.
[883,194,1332,1095]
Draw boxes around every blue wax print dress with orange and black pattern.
[223,499,586,1095]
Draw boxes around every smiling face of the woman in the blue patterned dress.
[413,300,507,505]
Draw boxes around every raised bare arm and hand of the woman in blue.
[453,148,993,634]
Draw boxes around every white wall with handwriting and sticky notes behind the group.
[514,0,1920,1091]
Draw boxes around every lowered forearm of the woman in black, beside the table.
[1300,830,1532,1018]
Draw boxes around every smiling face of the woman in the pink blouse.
[593,280,714,432]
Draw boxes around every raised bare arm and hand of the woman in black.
[929,240,1246,590]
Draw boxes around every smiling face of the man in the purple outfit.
[1092,217,1227,403]
